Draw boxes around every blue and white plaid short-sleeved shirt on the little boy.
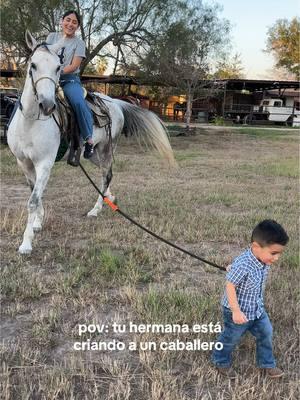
[222,249,270,320]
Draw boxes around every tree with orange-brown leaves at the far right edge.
[266,17,300,79]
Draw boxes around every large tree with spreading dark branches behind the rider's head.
[1,0,182,72]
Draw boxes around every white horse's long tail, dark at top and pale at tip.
[115,100,176,166]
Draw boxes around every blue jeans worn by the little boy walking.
[212,307,276,368]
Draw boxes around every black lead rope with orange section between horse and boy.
[79,163,226,271]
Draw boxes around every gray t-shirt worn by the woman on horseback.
[46,32,85,74]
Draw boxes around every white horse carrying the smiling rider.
[7,32,174,254]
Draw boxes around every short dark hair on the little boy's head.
[251,219,289,247]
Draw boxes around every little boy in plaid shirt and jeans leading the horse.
[212,220,289,379]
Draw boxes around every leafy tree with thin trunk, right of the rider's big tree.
[133,2,229,132]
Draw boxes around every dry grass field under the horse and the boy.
[0,127,300,400]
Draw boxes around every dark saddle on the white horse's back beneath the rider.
[54,87,112,167]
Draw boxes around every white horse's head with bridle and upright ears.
[25,31,62,115]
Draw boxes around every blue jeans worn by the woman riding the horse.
[60,74,93,140]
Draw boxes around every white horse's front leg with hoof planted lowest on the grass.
[19,164,51,254]
